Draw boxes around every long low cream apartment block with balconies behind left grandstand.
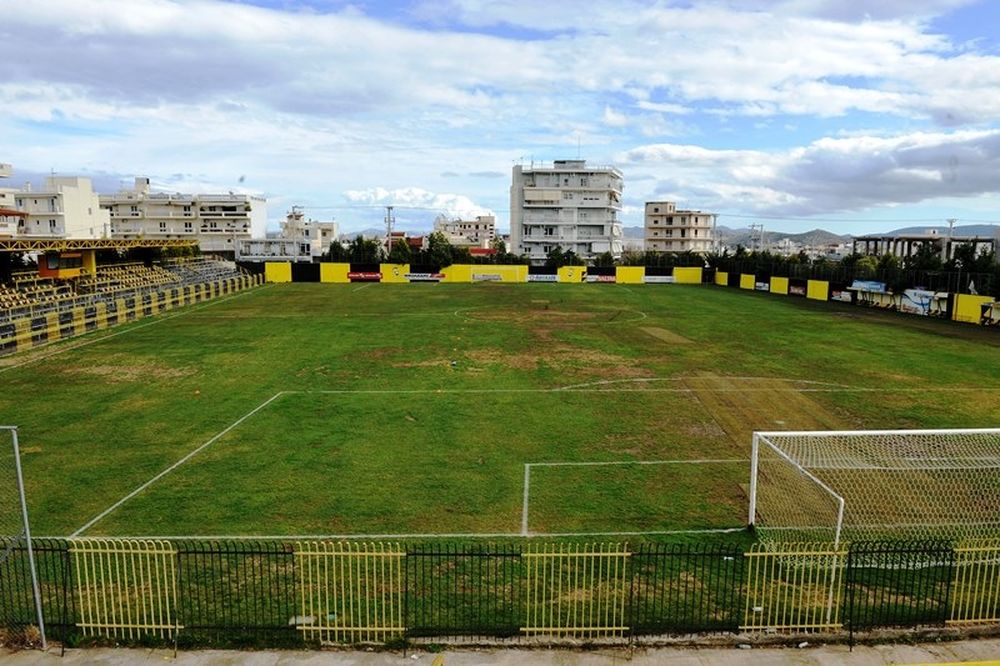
[100,178,267,254]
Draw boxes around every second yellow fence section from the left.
[295,542,406,643]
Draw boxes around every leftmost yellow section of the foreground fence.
[69,538,181,639]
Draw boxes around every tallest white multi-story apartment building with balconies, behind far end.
[510,160,624,264]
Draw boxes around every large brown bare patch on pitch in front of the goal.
[683,375,844,450]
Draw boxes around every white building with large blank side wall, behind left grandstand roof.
[8,176,109,238]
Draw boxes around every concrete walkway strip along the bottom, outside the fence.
[0,639,1000,666]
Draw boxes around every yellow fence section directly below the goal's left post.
[740,543,847,632]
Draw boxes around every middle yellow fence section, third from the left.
[521,544,631,638]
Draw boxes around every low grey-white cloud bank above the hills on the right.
[618,130,1000,215]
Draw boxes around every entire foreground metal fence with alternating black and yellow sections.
[0,539,1000,647]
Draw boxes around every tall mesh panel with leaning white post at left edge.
[0,426,47,649]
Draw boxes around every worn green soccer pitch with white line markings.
[0,284,1000,538]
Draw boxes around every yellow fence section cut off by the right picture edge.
[947,539,1000,625]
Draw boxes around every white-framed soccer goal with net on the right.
[749,428,1000,544]
